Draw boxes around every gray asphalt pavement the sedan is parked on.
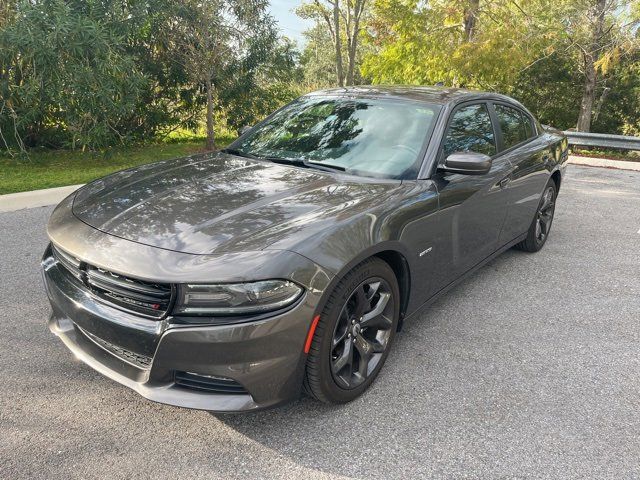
[0,167,640,479]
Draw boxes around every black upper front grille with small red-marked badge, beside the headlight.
[52,246,173,319]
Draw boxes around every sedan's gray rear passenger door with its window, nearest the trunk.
[493,102,552,245]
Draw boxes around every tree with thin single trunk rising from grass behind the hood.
[174,0,277,149]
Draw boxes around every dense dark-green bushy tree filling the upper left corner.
[0,0,205,149]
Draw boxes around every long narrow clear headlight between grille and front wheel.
[175,280,302,316]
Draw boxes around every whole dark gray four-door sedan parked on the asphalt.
[42,87,567,412]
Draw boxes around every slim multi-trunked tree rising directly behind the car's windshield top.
[296,0,367,87]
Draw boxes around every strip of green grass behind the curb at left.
[0,136,232,195]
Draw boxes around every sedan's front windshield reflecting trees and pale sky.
[228,97,440,179]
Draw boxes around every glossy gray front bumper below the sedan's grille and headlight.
[43,250,328,412]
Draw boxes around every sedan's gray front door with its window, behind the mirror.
[432,101,512,286]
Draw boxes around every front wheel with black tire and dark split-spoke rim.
[303,258,400,403]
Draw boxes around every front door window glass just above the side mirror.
[444,104,496,157]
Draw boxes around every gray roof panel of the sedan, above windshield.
[307,85,519,109]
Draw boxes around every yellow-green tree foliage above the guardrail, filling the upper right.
[362,0,640,133]
